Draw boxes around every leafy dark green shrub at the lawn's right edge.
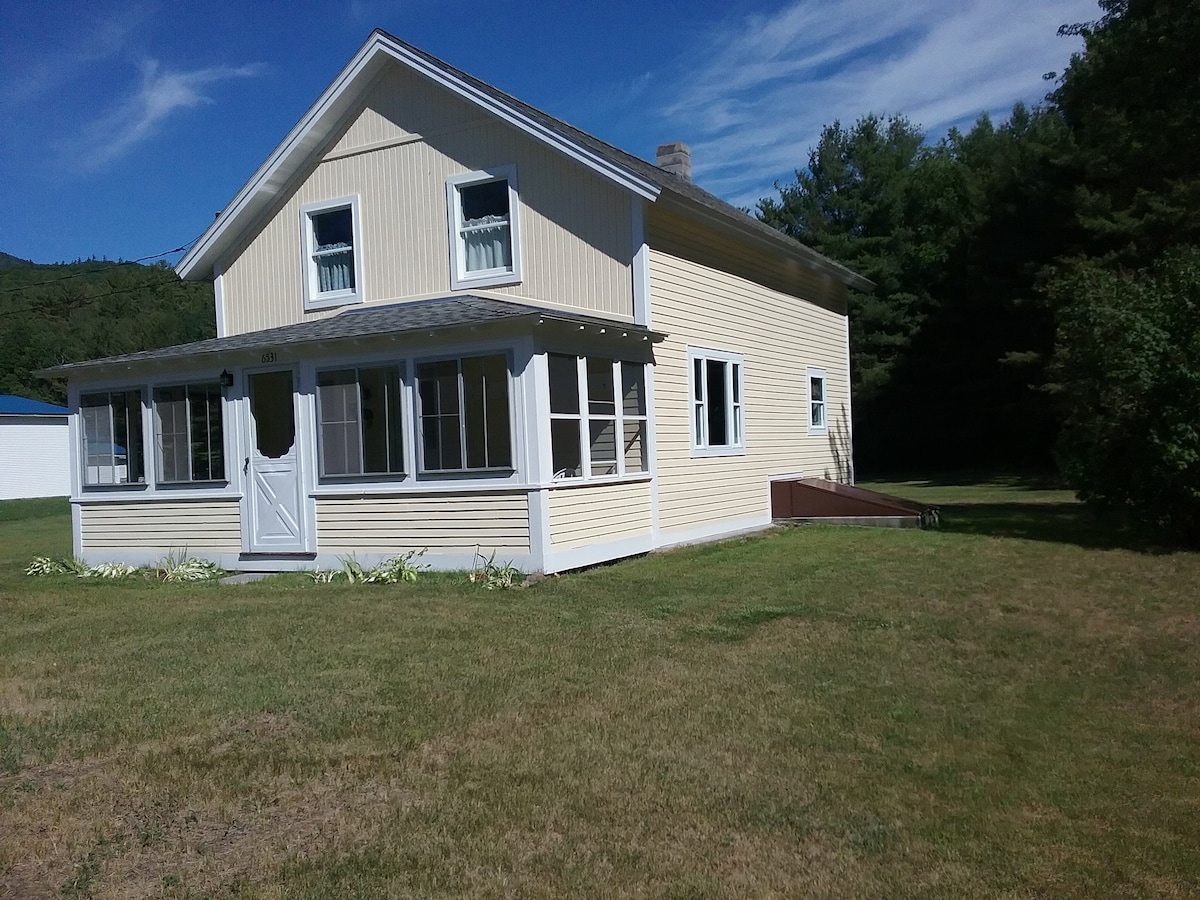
[1052,248,1200,544]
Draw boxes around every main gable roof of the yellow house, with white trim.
[175,29,874,290]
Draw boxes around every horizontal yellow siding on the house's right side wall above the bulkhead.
[650,250,850,539]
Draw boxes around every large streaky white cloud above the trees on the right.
[659,0,1099,206]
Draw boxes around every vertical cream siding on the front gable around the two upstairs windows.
[222,65,632,335]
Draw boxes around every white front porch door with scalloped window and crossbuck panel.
[244,370,305,553]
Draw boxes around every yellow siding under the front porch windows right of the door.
[317,491,529,556]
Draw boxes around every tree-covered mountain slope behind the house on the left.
[0,259,216,403]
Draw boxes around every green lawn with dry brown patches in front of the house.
[0,489,1200,898]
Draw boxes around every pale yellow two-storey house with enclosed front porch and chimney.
[47,31,871,572]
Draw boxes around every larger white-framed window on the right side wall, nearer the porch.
[688,349,745,456]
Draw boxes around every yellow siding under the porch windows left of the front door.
[79,499,241,556]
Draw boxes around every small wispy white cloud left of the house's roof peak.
[71,60,263,170]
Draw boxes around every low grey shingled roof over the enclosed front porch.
[36,294,666,378]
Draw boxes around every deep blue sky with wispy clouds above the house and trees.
[0,0,1098,263]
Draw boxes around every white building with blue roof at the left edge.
[0,394,71,500]
